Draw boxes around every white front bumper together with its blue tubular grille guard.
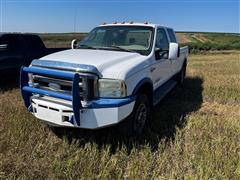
[20,62,135,129]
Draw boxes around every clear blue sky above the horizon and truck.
[0,0,240,33]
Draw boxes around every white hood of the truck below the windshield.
[40,49,146,79]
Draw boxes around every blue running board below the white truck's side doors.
[153,80,177,106]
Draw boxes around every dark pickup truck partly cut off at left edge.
[0,33,66,75]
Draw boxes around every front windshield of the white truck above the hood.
[77,26,153,55]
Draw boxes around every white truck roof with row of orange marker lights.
[99,22,172,29]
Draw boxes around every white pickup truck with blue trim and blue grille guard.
[20,23,188,135]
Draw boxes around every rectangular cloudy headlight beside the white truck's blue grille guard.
[98,79,126,98]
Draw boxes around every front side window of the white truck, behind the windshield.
[156,28,169,50]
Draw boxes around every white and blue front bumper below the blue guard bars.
[32,97,135,129]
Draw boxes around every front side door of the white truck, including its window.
[150,28,172,89]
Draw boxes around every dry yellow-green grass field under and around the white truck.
[0,51,240,179]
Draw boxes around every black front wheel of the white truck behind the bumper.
[118,94,150,136]
